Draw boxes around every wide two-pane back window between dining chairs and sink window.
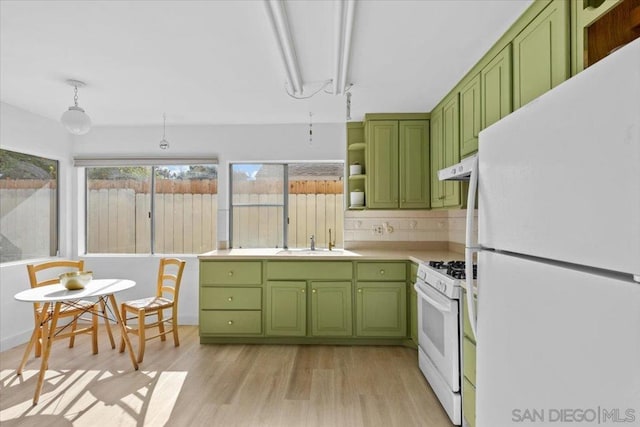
[85,161,218,254]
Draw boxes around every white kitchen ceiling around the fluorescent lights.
[0,0,531,126]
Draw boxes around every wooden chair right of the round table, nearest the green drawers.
[120,258,186,363]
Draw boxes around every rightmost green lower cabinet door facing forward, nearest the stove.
[356,282,407,337]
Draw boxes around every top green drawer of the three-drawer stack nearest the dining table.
[200,261,262,285]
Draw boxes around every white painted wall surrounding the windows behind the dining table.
[0,104,346,350]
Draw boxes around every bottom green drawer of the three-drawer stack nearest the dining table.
[200,310,262,335]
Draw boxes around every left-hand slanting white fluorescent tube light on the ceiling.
[264,0,303,96]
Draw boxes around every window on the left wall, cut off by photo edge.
[0,150,58,262]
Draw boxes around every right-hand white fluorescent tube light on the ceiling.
[333,0,355,95]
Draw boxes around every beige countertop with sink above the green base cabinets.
[198,247,464,263]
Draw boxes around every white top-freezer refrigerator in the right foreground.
[475,40,640,427]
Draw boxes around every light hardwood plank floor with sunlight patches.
[0,326,452,427]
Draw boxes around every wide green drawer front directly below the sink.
[267,261,353,280]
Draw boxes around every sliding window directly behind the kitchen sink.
[230,163,344,248]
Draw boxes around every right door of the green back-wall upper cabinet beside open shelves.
[399,120,430,209]
